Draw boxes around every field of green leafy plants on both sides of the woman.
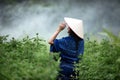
[0,31,120,80]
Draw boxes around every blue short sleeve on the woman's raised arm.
[50,39,63,52]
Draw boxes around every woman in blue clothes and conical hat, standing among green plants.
[48,17,84,80]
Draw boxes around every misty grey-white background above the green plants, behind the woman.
[0,0,120,39]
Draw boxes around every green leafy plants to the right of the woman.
[79,29,120,80]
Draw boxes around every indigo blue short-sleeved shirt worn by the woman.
[50,36,84,64]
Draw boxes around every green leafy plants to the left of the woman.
[0,35,59,80]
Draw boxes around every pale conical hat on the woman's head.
[64,17,84,39]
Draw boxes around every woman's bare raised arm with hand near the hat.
[48,22,66,44]
